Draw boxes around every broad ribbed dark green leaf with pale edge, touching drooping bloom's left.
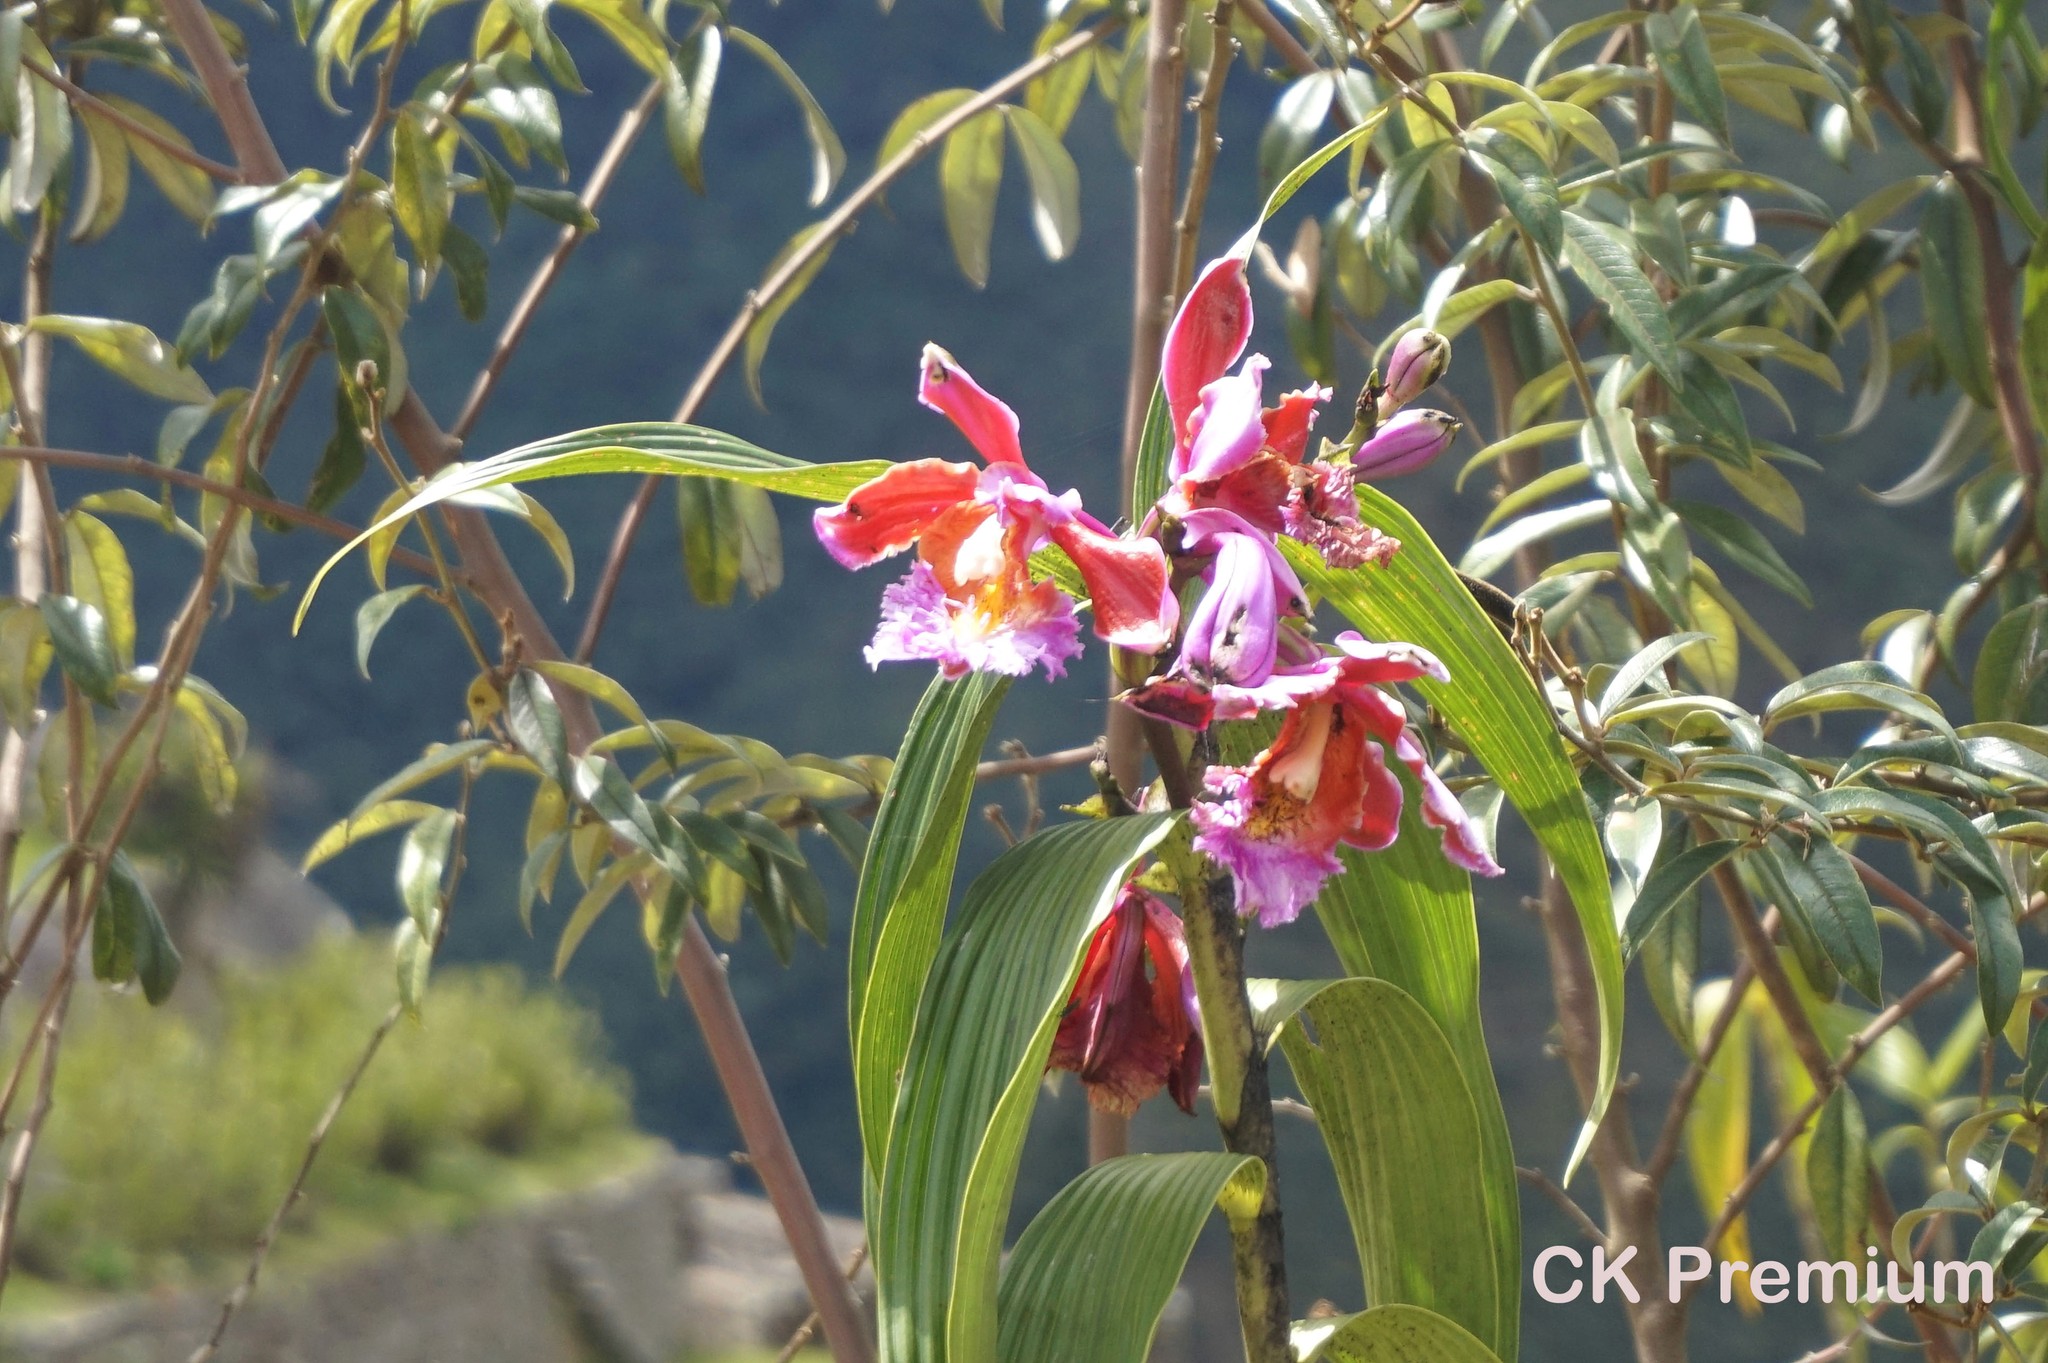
[868,815,1178,1363]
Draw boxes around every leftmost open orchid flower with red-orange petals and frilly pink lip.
[813,346,1180,677]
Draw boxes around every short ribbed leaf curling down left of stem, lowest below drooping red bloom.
[995,1152,1266,1363]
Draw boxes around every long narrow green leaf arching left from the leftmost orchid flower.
[293,419,889,630]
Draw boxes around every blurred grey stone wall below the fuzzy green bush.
[0,1152,866,1363]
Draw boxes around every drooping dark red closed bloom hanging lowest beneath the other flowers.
[1047,884,1202,1115]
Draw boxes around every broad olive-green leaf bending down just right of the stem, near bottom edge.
[1280,980,1513,1338]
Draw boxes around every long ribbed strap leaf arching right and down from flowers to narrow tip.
[1282,485,1622,1179]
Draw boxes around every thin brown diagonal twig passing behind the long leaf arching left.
[575,16,1124,661]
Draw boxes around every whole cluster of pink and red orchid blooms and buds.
[815,256,1499,1111]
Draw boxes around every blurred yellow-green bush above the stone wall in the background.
[20,939,643,1289]
